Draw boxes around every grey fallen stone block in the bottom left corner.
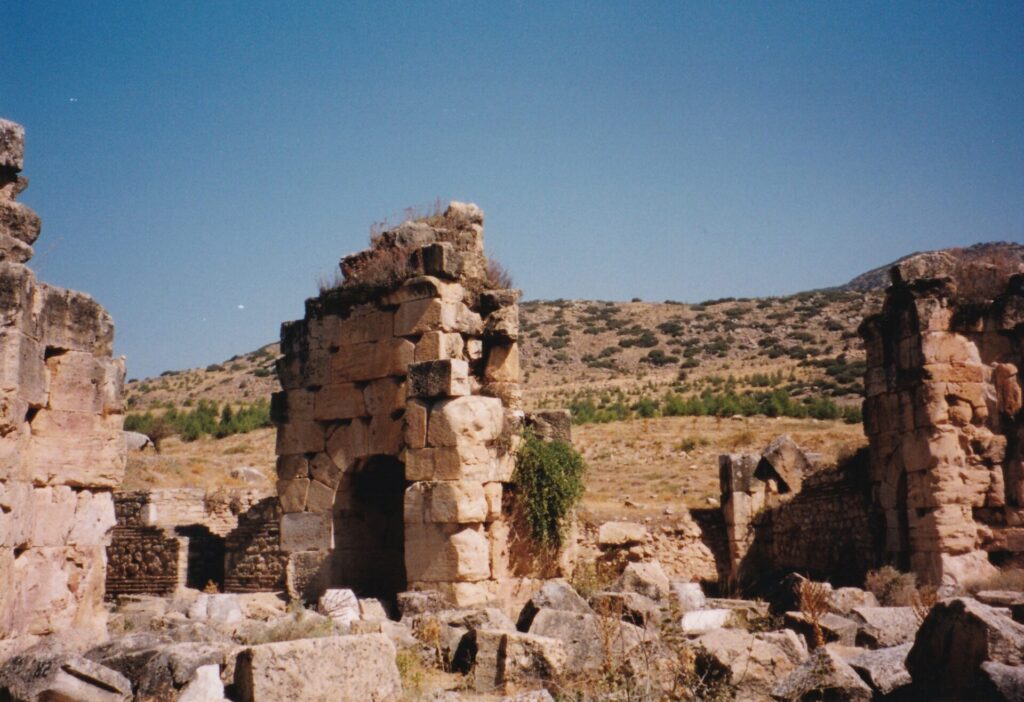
[0,645,132,702]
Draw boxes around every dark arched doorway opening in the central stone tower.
[333,455,406,603]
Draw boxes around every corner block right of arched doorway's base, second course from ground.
[406,523,490,582]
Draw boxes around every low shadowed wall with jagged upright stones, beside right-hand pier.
[719,437,878,585]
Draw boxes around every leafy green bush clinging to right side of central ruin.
[512,432,587,546]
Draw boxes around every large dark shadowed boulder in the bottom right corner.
[906,598,1024,699]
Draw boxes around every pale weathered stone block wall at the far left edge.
[0,120,125,639]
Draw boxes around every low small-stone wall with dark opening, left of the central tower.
[106,488,285,600]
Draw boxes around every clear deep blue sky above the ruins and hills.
[0,0,1024,377]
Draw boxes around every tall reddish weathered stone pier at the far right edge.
[860,262,1024,583]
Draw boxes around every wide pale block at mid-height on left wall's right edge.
[27,409,127,488]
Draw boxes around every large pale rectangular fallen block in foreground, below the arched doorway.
[234,633,401,702]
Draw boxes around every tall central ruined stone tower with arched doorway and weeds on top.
[271,203,522,604]
